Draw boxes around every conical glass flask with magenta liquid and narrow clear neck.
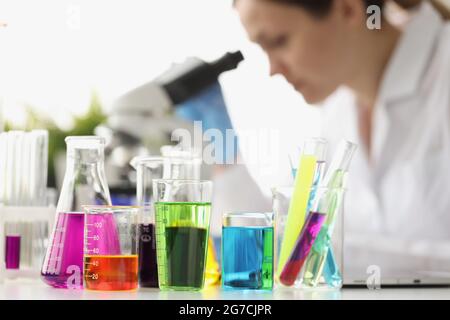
[41,136,111,289]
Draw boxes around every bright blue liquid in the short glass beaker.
[222,227,274,290]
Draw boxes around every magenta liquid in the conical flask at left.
[41,212,84,289]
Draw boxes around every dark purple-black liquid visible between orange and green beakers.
[139,224,158,288]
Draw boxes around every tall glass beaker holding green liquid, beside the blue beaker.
[153,179,212,290]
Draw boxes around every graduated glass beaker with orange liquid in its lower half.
[84,206,139,291]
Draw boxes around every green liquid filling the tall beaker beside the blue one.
[155,202,211,290]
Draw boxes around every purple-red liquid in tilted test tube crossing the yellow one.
[280,212,326,286]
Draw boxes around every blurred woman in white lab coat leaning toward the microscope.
[234,0,450,279]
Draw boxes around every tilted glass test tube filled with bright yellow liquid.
[276,138,327,279]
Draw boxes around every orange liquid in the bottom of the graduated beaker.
[84,255,138,291]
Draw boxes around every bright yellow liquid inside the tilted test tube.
[276,155,317,278]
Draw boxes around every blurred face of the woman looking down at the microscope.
[236,0,355,103]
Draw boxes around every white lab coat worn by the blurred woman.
[324,3,450,277]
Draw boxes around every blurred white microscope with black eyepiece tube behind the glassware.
[95,51,244,205]
